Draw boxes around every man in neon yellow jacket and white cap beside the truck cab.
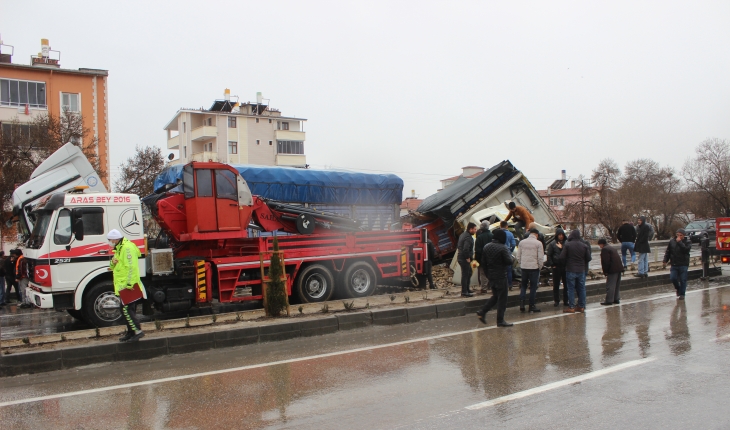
[106,229,144,342]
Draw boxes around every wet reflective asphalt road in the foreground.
[0,283,730,429]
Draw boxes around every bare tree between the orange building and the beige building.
[114,146,165,197]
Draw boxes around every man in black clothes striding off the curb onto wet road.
[477,229,513,327]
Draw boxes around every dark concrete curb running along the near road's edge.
[0,268,722,377]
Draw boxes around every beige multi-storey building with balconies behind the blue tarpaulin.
[165,89,307,167]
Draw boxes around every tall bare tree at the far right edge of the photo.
[682,138,730,216]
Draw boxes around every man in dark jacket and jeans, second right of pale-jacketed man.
[560,229,591,313]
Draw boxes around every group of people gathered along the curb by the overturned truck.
[457,203,692,327]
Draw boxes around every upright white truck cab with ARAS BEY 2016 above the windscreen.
[23,191,146,326]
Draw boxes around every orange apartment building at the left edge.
[0,39,110,187]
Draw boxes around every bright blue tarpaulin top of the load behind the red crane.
[154,164,403,205]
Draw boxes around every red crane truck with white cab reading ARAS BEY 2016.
[24,162,427,326]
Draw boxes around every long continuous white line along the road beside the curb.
[0,284,730,408]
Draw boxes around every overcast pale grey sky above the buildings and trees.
[0,0,730,198]
